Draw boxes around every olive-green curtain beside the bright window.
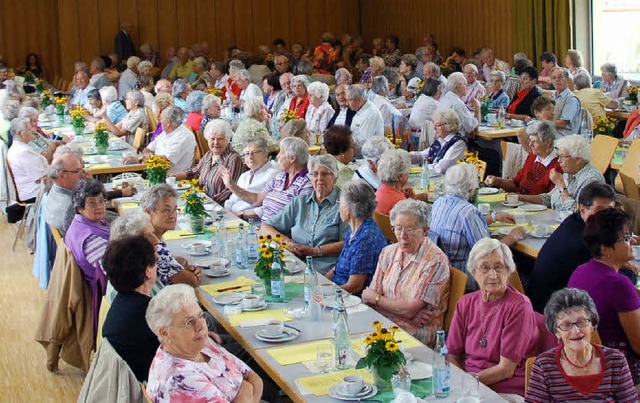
[512,0,572,66]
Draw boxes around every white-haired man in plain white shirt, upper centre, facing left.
[346,84,384,155]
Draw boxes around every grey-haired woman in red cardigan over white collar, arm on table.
[485,120,562,195]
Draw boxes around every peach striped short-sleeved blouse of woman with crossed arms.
[369,237,451,347]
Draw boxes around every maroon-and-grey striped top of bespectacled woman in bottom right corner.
[525,345,638,403]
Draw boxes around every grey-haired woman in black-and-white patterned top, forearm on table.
[142,184,201,287]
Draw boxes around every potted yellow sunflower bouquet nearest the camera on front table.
[356,321,407,381]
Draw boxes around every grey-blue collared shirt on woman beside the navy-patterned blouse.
[267,188,348,275]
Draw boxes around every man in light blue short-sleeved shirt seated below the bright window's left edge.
[551,67,582,137]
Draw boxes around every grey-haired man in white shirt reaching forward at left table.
[124,106,196,173]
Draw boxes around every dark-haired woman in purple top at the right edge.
[568,208,640,385]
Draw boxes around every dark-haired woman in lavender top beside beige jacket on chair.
[64,180,109,335]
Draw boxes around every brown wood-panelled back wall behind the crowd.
[0,0,517,79]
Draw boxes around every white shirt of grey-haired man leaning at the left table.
[147,125,196,173]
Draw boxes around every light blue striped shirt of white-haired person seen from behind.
[429,194,490,289]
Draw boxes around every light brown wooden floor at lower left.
[0,215,84,402]
